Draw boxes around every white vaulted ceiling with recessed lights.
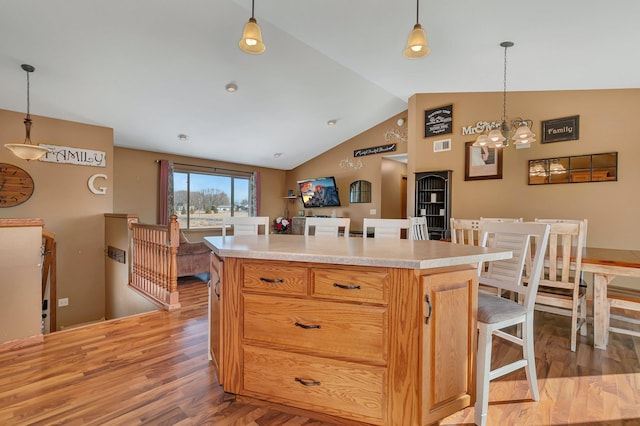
[0,0,640,170]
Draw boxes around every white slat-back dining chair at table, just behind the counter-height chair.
[525,220,587,352]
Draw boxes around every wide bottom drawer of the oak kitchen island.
[243,345,386,424]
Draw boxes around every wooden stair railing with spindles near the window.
[129,215,180,311]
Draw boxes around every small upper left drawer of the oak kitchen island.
[242,262,307,295]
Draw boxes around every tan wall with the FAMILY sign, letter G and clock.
[0,110,114,326]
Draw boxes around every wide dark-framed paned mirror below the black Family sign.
[529,152,618,185]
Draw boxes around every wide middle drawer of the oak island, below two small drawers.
[243,294,387,363]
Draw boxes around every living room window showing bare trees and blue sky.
[173,170,251,229]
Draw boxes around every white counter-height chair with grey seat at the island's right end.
[474,222,550,426]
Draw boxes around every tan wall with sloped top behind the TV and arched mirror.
[283,112,407,231]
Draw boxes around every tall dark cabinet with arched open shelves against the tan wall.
[415,170,451,240]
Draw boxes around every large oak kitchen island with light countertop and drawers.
[205,235,511,425]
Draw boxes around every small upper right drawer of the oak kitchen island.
[311,267,389,303]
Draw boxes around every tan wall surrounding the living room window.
[114,147,287,236]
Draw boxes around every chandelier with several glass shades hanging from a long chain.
[473,41,536,148]
